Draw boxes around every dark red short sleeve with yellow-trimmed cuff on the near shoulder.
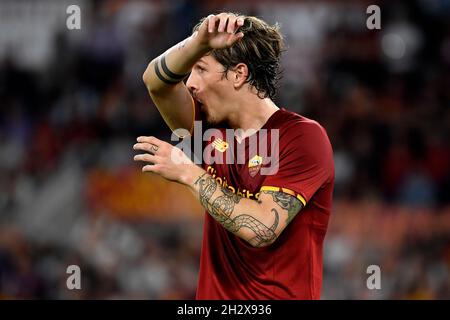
[260,121,334,205]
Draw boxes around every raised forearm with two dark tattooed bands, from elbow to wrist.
[143,34,210,93]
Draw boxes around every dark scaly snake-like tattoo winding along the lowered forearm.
[195,174,279,247]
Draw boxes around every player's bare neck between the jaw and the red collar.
[228,95,279,140]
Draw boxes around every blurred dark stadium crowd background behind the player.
[0,0,450,299]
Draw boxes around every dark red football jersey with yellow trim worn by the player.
[190,104,334,300]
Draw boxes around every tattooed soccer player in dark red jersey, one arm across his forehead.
[133,13,334,300]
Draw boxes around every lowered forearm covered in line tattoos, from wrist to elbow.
[183,169,280,247]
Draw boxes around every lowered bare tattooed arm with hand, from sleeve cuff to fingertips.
[133,137,302,247]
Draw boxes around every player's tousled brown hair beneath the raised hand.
[193,13,284,99]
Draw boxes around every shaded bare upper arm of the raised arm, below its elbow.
[143,61,194,137]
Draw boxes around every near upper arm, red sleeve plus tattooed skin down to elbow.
[248,125,334,242]
